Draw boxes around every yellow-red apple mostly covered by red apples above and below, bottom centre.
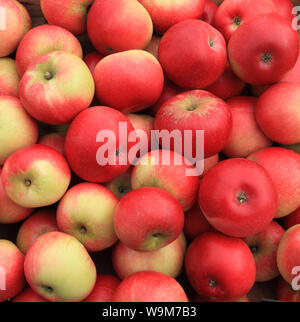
[112,233,186,280]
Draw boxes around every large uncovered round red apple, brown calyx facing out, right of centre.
[198,158,278,236]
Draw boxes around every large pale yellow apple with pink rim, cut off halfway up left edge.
[0,96,39,165]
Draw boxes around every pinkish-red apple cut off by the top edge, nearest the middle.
[139,0,205,34]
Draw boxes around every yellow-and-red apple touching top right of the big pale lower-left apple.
[56,182,118,252]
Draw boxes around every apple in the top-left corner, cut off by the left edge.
[0,0,31,57]
